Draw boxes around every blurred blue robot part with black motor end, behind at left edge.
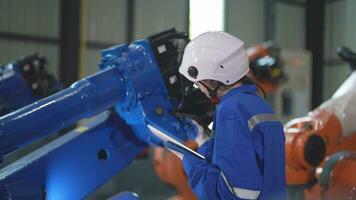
[0,54,62,116]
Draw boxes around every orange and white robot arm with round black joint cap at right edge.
[285,46,356,199]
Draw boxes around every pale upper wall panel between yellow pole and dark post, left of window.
[87,0,127,43]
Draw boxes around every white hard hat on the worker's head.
[179,31,249,85]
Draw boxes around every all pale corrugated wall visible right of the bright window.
[226,0,356,99]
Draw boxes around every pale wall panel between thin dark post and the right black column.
[275,3,305,49]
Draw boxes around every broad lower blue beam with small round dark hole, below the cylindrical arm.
[0,112,145,200]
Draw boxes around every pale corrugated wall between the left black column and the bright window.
[84,0,189,75]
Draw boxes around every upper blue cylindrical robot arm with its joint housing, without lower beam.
[0,40,192,158]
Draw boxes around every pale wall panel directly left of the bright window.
[133,0,189,39]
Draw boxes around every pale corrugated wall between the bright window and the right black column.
[226,0,305,49]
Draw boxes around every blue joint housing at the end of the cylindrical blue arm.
[100,40,187,145]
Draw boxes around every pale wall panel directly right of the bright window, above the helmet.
[226,0,265,47]
